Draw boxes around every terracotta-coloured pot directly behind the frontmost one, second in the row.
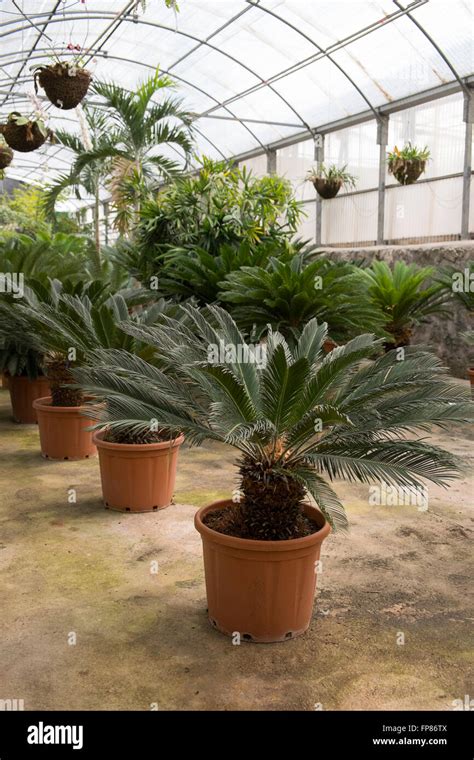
[93,430,184,512]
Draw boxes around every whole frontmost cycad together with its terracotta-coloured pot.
[72,306,473,642]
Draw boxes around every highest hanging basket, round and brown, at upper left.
[34,63,92,111]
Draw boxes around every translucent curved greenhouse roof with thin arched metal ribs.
[0,0,473,190]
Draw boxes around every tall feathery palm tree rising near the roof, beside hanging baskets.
[43,71,193,239]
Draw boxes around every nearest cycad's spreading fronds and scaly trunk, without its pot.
[74,306,473,540]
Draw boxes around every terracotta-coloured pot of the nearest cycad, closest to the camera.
[194,500,331,642]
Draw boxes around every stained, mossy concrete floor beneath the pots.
[0,391,474,710]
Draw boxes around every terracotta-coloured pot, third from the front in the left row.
[33,396,97,459]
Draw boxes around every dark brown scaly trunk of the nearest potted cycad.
[239,457,305,541]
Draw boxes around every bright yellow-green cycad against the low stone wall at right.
[359,261,449,350]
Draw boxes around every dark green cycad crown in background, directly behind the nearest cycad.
[219,253,384,341]
